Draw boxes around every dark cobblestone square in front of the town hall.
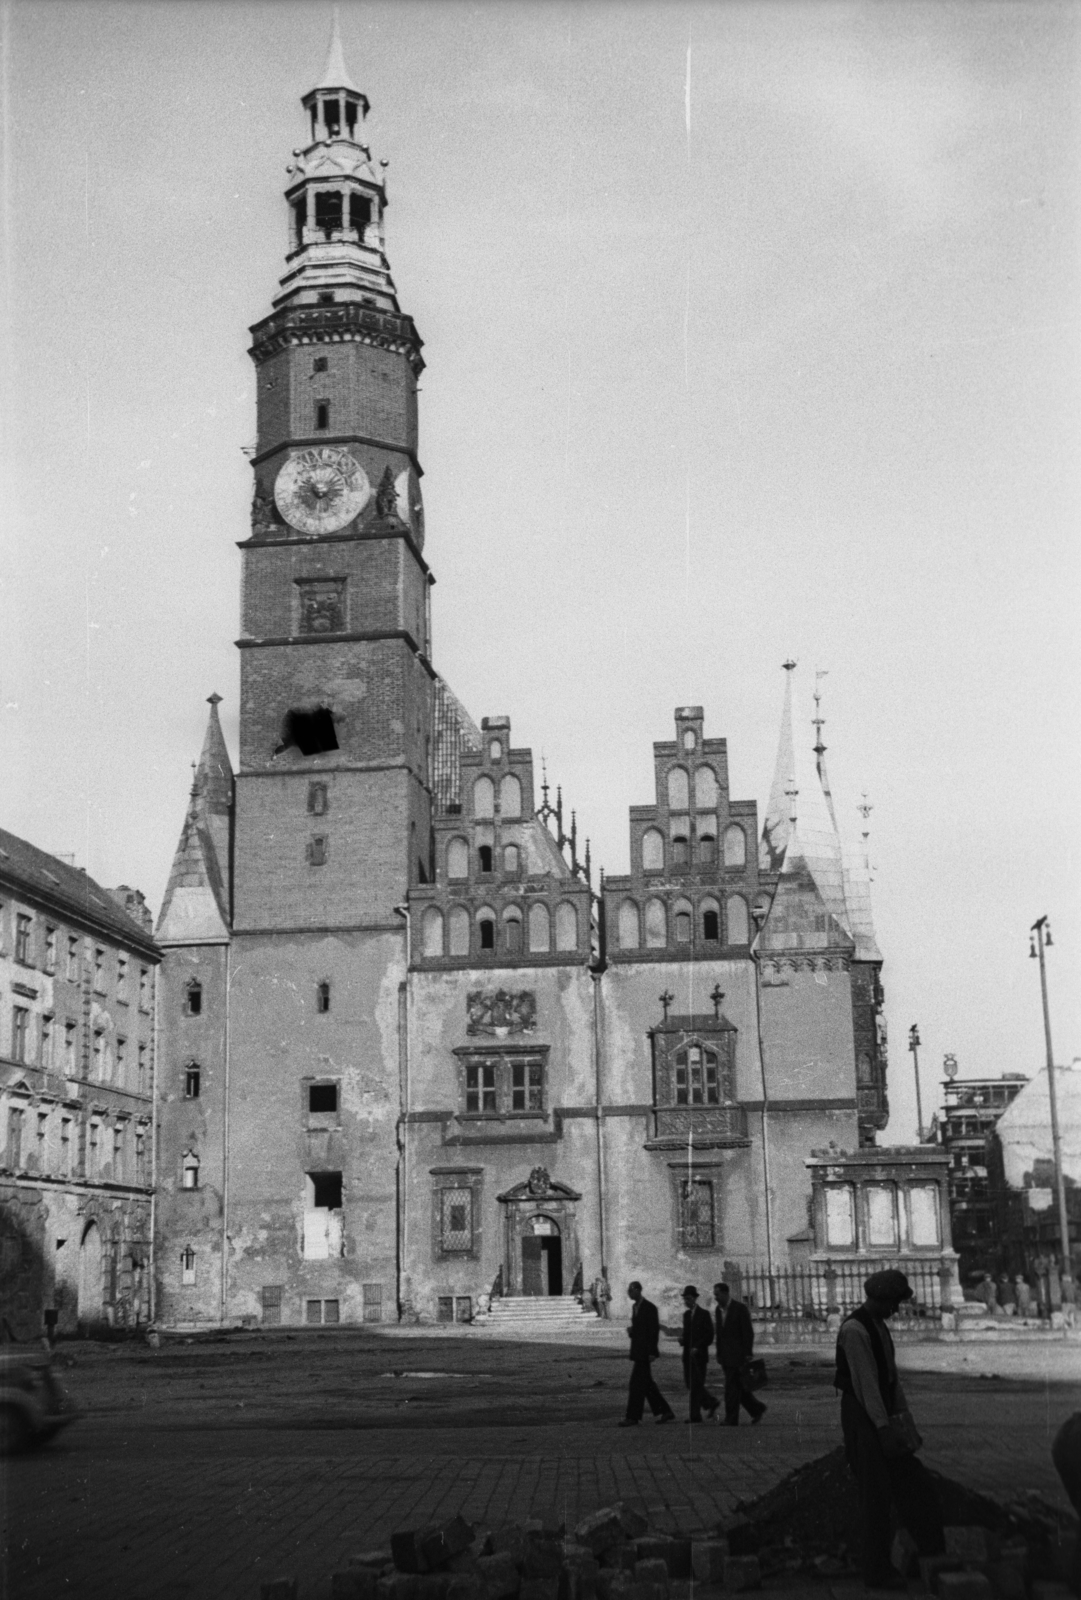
[0,1330,1081,1600]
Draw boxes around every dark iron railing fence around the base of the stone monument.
[724,1258,950,1328]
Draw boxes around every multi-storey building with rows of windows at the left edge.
[0,829,160,1339]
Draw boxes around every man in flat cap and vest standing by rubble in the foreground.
[833,1270,945,1589]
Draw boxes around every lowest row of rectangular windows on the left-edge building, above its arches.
[5,1106,149,1187]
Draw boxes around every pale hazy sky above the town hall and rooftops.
[0,0,1081,1141]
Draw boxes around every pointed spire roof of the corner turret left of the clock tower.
[155,694,233,946]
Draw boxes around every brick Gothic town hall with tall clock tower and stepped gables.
[157,28,948,1325]
